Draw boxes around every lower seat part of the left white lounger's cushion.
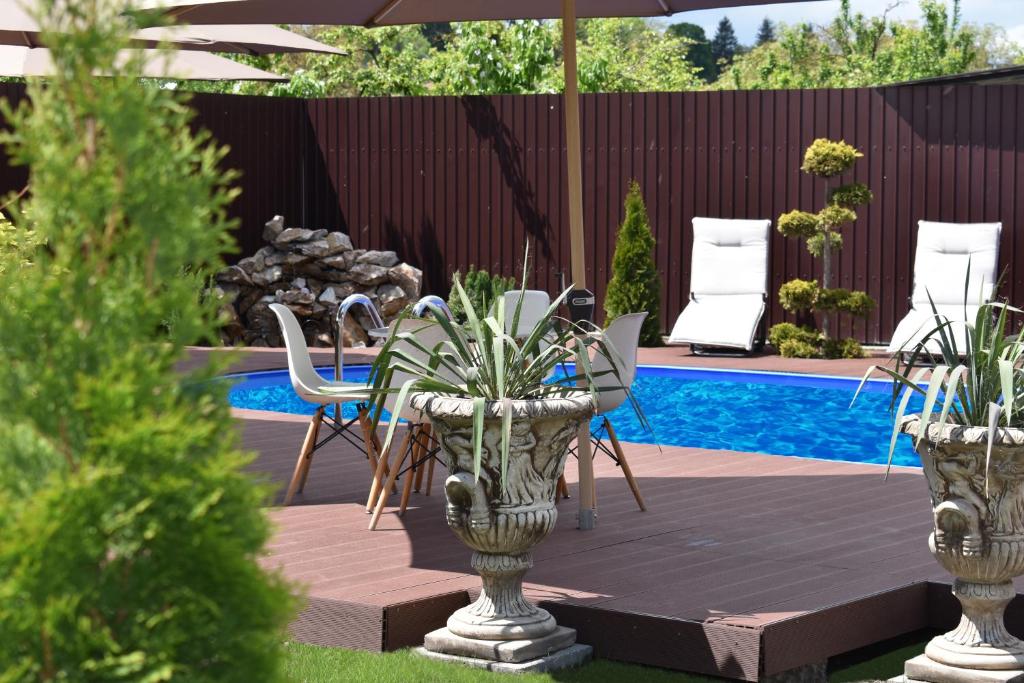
[669,294,765,351]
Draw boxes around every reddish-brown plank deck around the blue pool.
[197,349,1015,680]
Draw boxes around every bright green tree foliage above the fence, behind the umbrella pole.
[190,18,705,97]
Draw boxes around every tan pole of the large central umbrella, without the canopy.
[562,0,597,530]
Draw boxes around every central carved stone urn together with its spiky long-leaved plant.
[364,264,646,669]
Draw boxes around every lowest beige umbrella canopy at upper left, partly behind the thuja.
[0,45,288,81]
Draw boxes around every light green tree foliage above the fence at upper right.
[719,0,1007,89]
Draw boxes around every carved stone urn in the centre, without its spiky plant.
[412,393,594,672]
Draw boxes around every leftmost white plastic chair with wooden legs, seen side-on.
[270,303,377,506]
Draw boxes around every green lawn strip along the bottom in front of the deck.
[287,632,933,683]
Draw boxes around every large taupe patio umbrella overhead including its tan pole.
[149,0,808,528]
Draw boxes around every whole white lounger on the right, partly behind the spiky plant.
[889,220,1002,353]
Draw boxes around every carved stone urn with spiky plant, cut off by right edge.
[851,303,1024,681]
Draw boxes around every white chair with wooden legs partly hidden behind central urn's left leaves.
[367,318,447,530]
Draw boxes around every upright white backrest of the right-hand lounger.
[911,220,1002,311]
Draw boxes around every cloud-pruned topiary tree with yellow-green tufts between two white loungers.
[769,138,874,357]
